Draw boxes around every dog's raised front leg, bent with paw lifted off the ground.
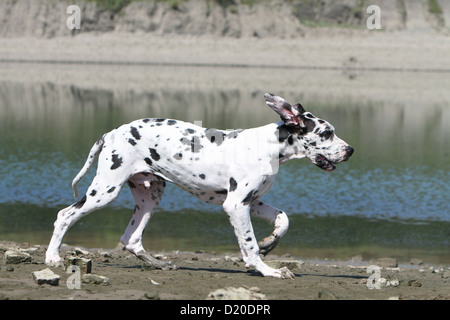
[250,200,289,255]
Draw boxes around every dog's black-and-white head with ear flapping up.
[264,93,354,172]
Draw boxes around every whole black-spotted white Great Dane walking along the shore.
[46,93,353,278]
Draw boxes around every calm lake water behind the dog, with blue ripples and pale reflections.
[0,63,450,263]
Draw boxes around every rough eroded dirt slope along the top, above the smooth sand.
[0,0,450,39]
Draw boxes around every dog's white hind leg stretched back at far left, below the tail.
[45,172,124,266]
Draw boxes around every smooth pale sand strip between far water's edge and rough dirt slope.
[0,28,450,72]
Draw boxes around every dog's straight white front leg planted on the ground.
[223,196,294,279]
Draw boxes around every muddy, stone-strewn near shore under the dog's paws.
[0,242,450,300]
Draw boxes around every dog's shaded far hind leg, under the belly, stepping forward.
[120,174,176,270]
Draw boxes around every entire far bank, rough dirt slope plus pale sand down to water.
[0,0,450,72]
